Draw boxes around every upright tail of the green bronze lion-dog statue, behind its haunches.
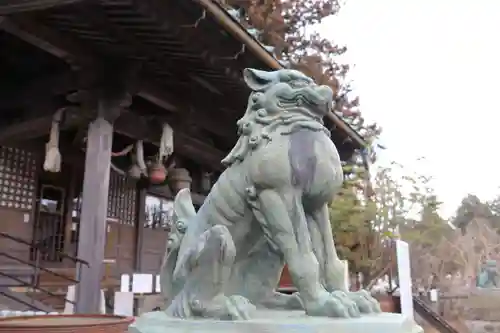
[160,188,196,307]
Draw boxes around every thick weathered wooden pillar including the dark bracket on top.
[72,59,135,314]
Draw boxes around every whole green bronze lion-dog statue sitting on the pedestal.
[161,69,380,319]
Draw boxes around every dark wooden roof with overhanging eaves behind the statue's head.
[0,0,365,170]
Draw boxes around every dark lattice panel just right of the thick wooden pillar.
[108,170,137,225]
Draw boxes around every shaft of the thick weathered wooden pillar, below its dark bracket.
[75,116,113,313]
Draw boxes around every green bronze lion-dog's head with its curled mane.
[222,68,333,166]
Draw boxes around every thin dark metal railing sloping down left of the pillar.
[0,232,89,311]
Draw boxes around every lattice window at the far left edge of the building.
[0,147,37,210]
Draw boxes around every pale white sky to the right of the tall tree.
[319,0,500,217]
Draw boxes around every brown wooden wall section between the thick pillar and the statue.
[75,171,172,278]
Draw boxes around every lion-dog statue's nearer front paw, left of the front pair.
[306,291,360,318]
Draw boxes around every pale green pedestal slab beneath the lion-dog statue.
[129,310,423,333]
